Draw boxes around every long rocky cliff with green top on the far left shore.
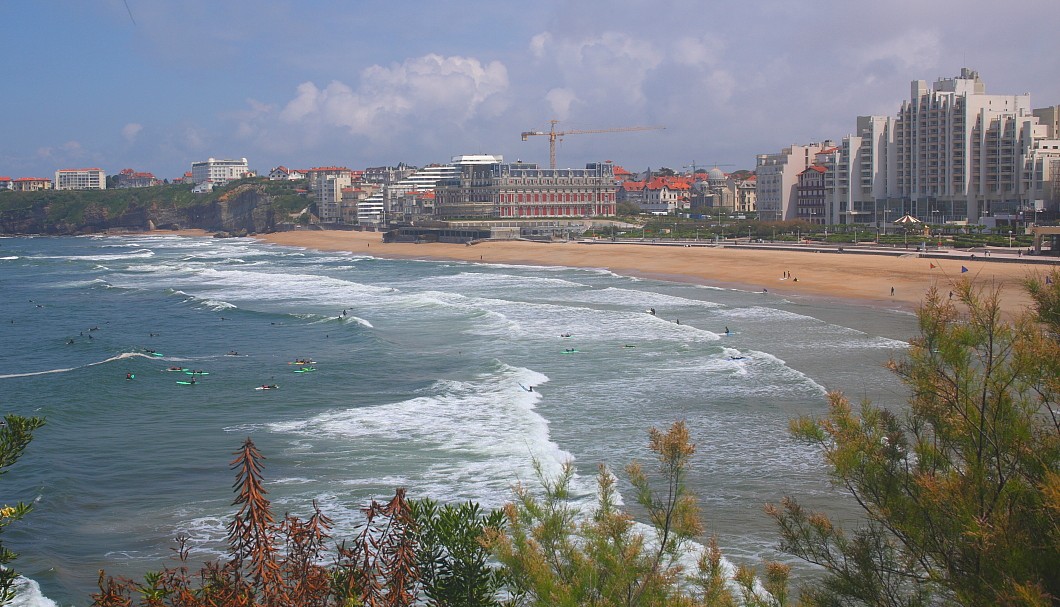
[0,180,308,235]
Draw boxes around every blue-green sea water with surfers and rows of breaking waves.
[0,235,916,605]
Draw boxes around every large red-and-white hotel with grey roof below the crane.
[435,157,618,219]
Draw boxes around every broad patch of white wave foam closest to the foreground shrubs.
[260,363,571,508]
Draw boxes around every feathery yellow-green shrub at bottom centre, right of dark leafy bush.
[487,422,771,607]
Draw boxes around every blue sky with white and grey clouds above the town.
[0,0,1060,178]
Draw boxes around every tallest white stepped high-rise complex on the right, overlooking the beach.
[822,68,1060,224]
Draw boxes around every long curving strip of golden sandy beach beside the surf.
[236,230,1053,315]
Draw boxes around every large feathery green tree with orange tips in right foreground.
[767,280,1060,606]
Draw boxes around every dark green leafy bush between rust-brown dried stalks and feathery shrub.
[409,499,505,607]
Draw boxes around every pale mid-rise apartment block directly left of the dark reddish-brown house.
[755,141,834,221]
